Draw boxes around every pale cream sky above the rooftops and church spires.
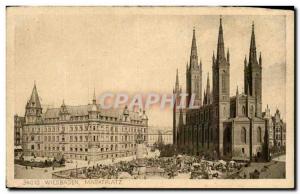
[13,9,286,127]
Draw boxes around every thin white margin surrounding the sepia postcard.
[0,0,300,193]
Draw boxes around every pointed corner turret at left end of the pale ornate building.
[25,83,42,124]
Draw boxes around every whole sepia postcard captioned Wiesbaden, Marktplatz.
[6,6,296,189]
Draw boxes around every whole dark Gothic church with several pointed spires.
[173,18,266,160]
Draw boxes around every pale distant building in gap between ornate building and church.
[148,126,173,147]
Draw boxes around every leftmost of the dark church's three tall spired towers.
[186,29,202,106]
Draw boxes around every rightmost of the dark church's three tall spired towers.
[244,23,262,118]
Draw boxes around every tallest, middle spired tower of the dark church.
[212,18,230,156]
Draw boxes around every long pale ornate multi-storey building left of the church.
[22,84,148,161]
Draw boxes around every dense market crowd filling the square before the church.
[70,155,252,179]
